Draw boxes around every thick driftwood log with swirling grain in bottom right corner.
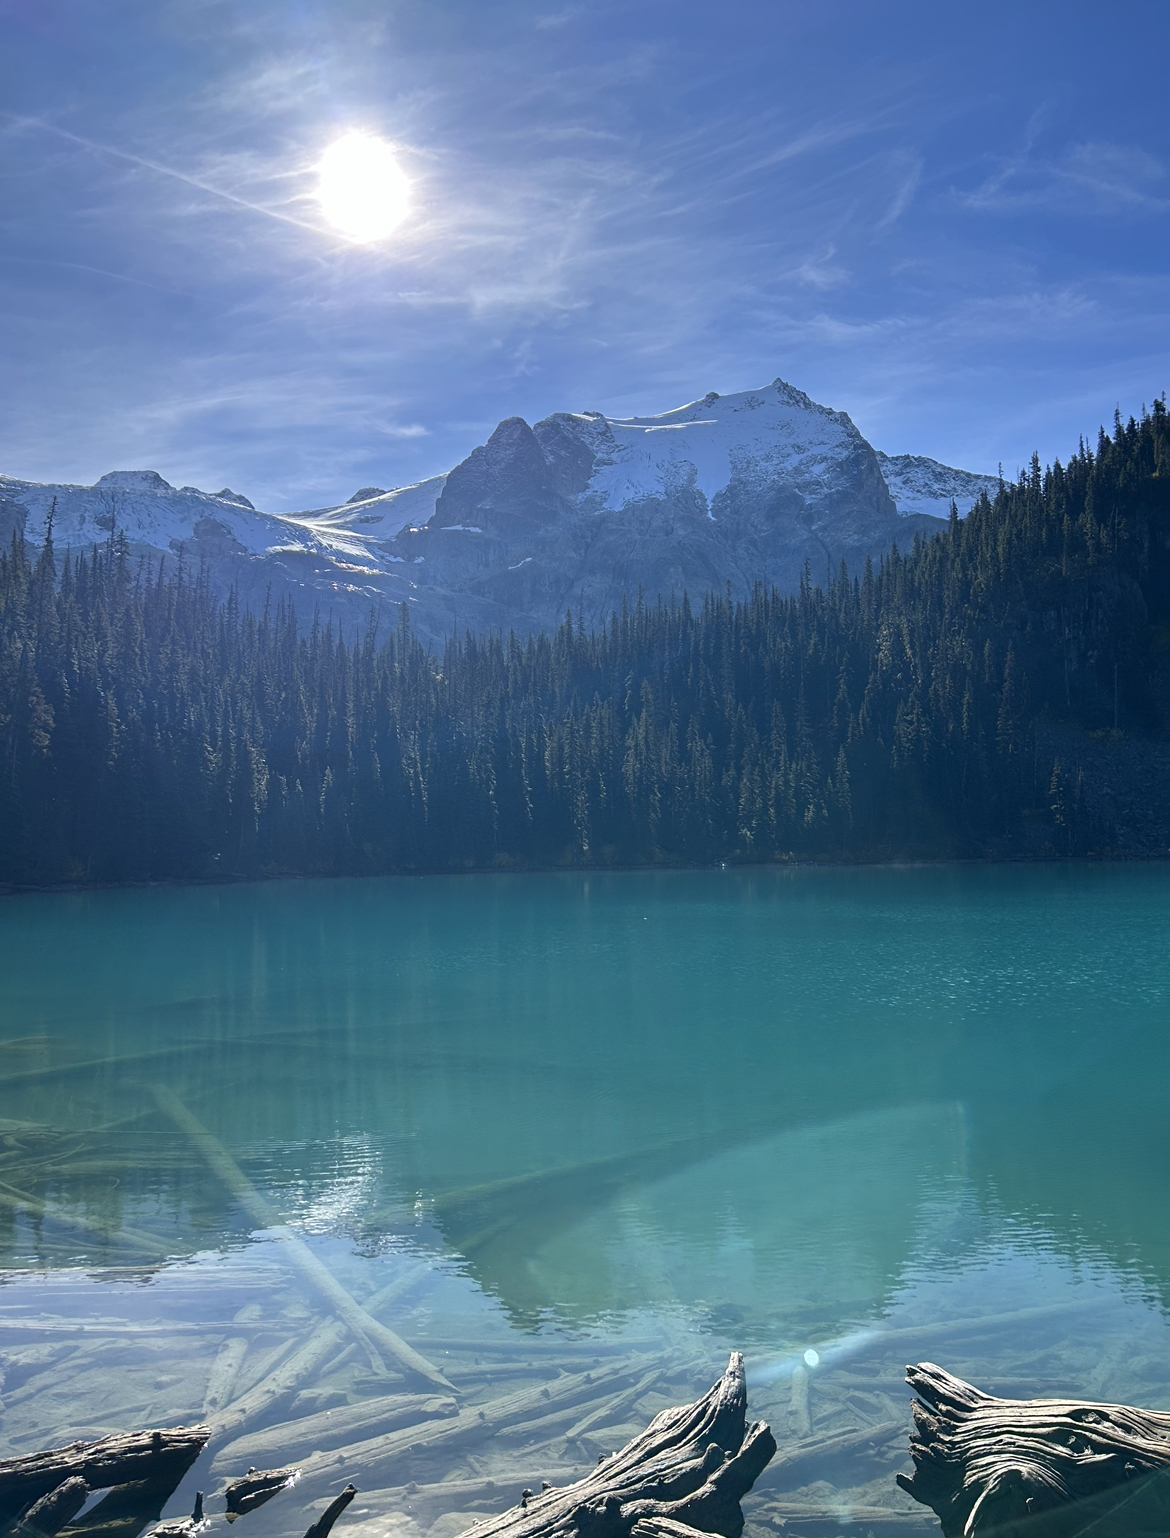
[898,1363,1170,1538]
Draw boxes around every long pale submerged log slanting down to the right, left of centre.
[151,1084,455,1393]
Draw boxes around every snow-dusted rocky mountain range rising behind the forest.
[0,380,998,640]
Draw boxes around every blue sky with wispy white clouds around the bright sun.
[0,0,1170,511]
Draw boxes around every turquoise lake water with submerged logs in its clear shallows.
[0,866,1170,1538]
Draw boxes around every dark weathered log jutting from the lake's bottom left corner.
[0,1426,211,1521]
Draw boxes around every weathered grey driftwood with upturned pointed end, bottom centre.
[442,1352,776,1538]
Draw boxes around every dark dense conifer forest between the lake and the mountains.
[0,401,1170,886]
